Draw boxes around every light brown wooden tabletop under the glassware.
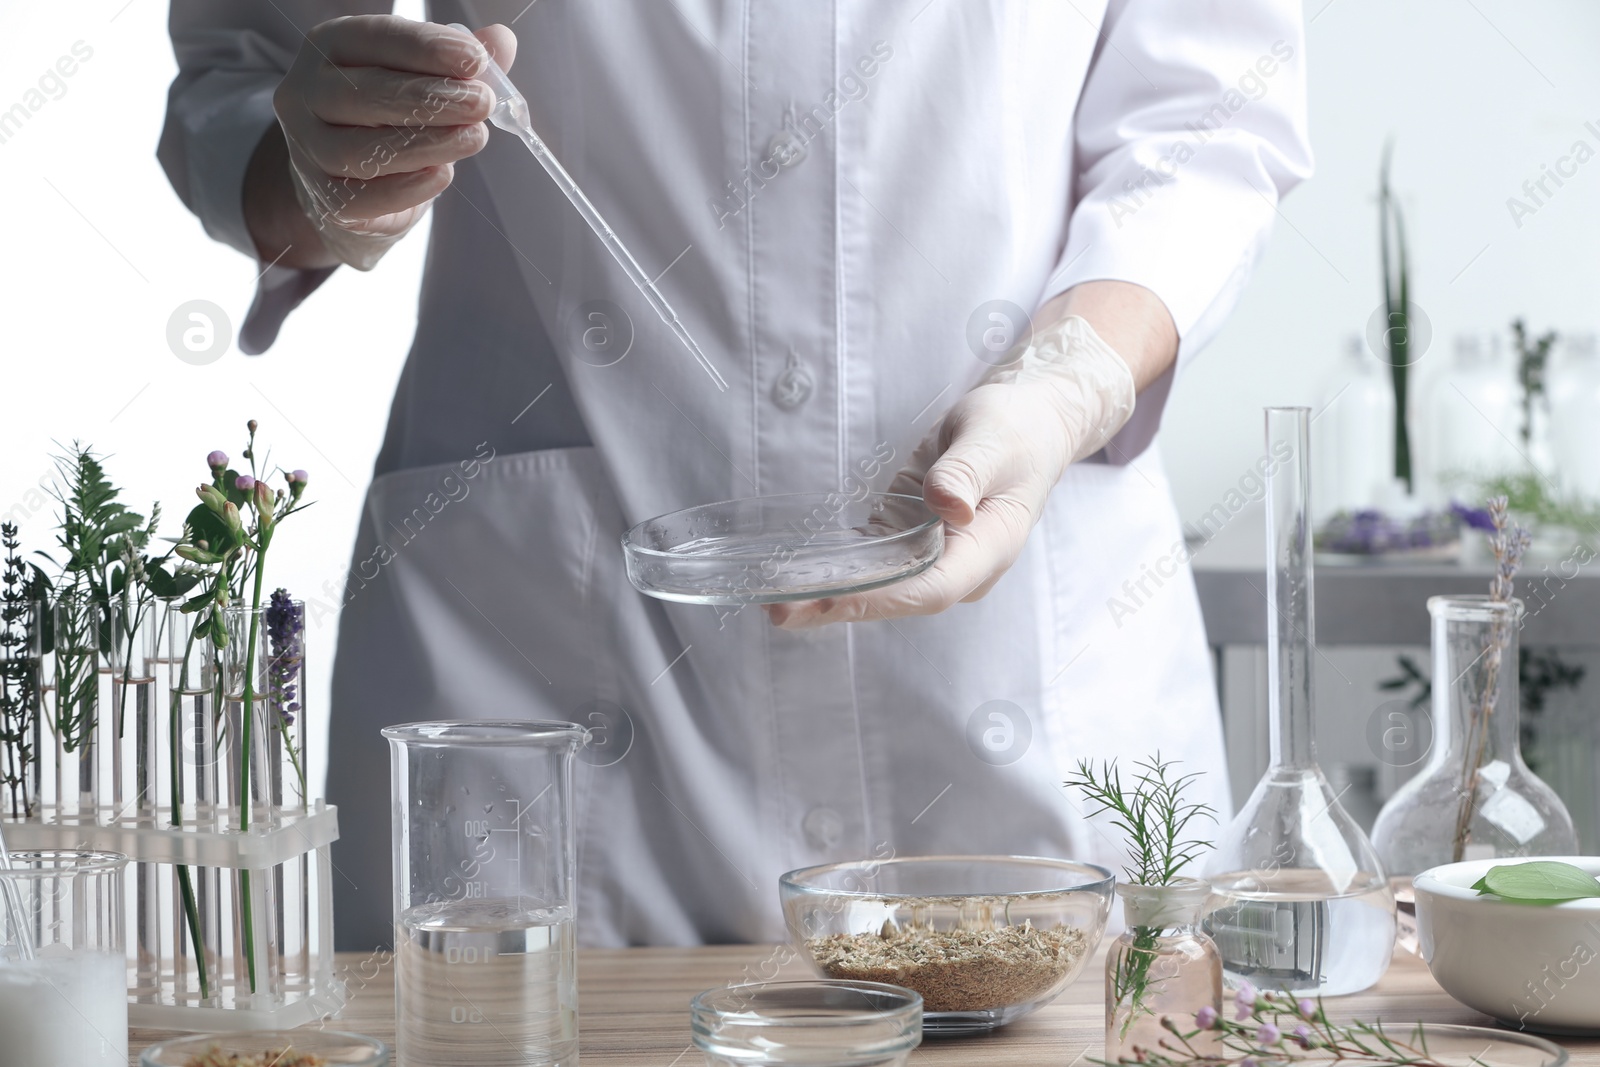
[130,945,1600,1067]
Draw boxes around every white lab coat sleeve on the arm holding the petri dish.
[1043,0,1312,464]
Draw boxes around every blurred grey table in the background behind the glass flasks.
[1190,518,1600,853]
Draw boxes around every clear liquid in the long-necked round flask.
[1202,870,1395,997]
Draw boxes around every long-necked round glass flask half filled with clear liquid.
[1205,408,1395,997]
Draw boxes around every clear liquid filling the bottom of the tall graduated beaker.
[395,901,578,1067]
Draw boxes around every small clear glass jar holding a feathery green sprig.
[1106,878,1222,1061]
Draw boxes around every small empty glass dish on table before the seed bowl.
[690,981,922,1067]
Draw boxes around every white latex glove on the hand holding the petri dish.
[766,315,1134,629]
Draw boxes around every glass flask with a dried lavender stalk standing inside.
[1373,597,1578,942]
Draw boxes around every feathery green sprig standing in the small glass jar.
[1066,752,1216,1037]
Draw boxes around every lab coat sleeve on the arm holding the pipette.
[157,0,394,354]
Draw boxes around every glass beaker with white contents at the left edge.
[0,849,128,1067]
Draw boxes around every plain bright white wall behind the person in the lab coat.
[0,0,1600,799]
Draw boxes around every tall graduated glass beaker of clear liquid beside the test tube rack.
[384,721,587,1067]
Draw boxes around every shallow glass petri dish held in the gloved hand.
[622,493,944,605]
